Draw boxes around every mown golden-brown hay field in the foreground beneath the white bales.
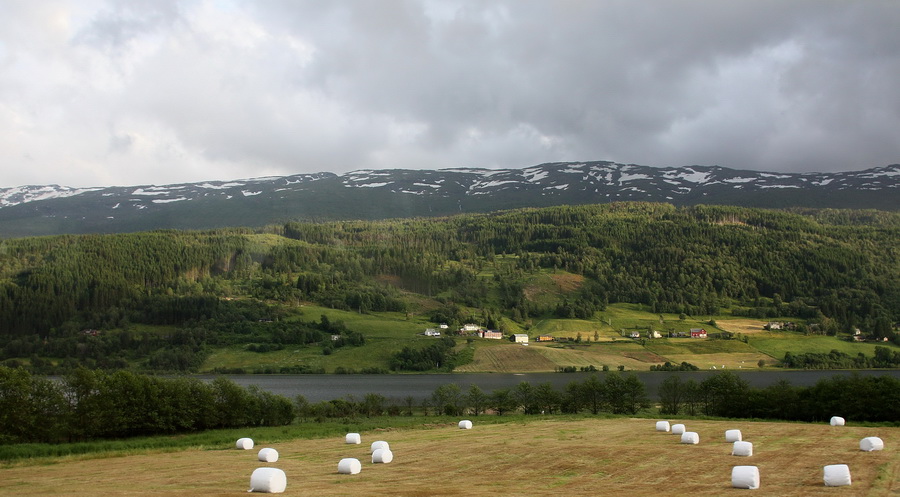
[0,417,900,497]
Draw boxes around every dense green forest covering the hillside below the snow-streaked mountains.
[0,203,900,372]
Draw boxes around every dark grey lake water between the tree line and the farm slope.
[200,370,900,404]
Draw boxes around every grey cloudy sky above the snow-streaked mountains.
[0,0,900,187]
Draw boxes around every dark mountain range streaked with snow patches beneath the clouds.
[0,161,900,237]
